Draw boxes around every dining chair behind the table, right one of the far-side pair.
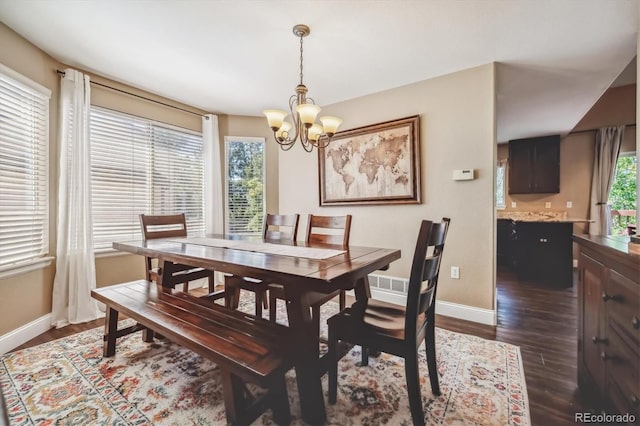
[268,214,351,335]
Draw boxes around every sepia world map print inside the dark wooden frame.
[323,126,413,201]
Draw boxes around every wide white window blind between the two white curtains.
[90,106,205,251]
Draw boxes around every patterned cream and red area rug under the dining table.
[0,296,530,426]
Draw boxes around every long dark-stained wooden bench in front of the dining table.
[91,280,294,424]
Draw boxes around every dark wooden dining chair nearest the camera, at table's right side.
[327,218,450,425]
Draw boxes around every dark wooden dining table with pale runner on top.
[113,235,400,424]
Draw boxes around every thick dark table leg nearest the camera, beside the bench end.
[285,286,327,425]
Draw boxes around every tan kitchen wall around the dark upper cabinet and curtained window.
[498,84,636,233]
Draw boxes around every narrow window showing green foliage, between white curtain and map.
[225,137,265,234]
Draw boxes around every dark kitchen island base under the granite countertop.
[511,221,573,287]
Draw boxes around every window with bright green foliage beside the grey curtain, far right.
[608,152,638,235]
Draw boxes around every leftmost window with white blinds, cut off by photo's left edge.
[0,64,51,270]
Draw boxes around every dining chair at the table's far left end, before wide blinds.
[140,213,216,299]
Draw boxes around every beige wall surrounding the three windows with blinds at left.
[0,23,278,336]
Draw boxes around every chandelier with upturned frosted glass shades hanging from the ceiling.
[263,24,342,152]
